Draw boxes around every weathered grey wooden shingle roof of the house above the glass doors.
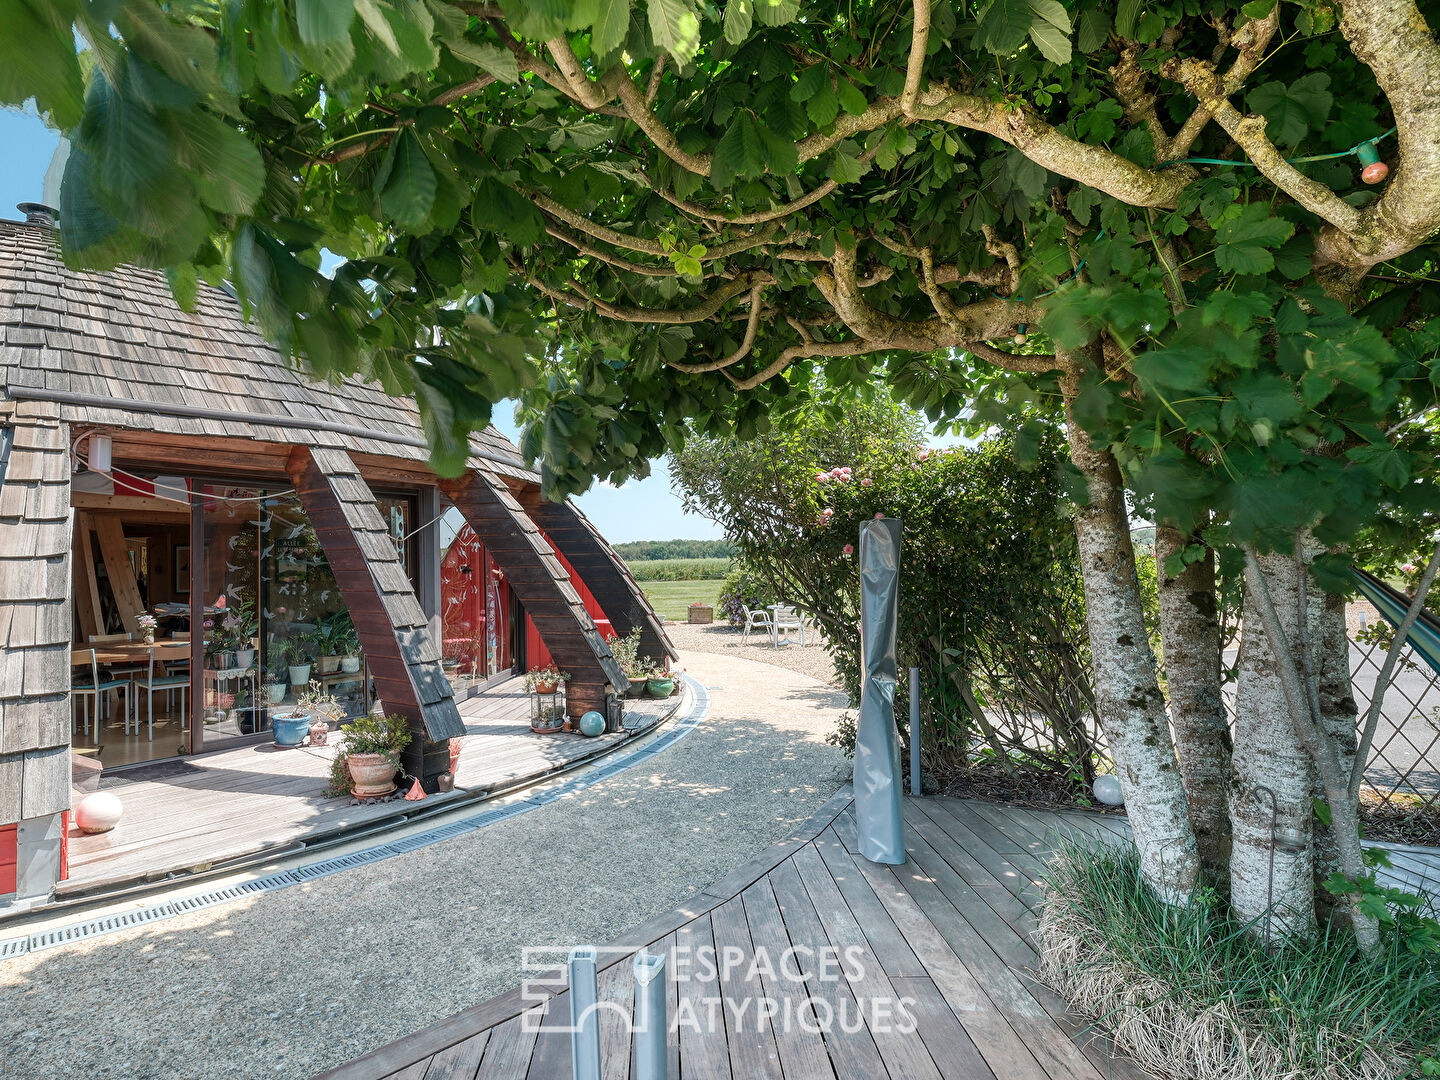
[0,220,539,482]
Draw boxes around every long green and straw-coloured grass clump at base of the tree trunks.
[1038,842,1440,1080]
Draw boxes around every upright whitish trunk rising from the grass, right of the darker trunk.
[1230,552,1319,940]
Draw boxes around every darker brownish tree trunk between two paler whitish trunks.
[1155,526,1231,880]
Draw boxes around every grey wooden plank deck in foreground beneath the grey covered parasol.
[324,792,1163,1080]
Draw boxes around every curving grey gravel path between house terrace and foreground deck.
[0,642,848,1080]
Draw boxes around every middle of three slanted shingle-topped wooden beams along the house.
[439,469,629,714]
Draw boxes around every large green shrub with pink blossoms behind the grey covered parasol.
[671,397,1096,786]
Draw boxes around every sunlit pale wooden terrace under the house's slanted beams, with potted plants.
[56,678,683,899]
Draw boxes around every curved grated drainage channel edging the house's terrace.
[0,675,710,959]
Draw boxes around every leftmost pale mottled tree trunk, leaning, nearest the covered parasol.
[1067,397,1200,903]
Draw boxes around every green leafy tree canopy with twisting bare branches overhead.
[0,0,1440,536]
